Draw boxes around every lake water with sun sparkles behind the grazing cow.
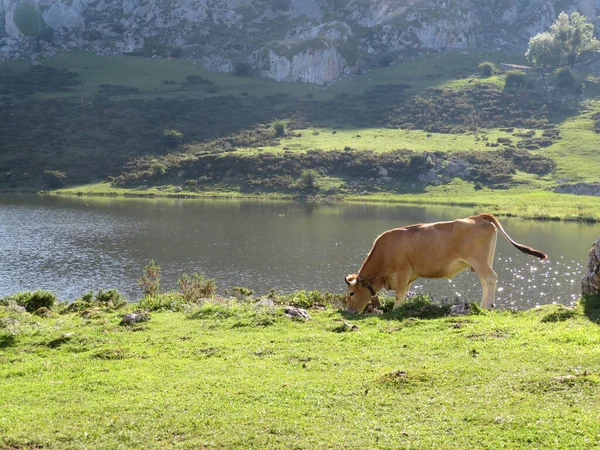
[0,195,600,309]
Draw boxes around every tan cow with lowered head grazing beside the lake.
[346,214,547,313]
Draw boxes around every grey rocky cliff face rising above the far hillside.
[0,0,600,83]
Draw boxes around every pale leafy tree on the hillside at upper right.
[525,12,600,69]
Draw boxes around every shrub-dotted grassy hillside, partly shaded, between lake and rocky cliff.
[0,53,600,220]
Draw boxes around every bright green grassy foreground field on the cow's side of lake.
[0,301,600,450]
